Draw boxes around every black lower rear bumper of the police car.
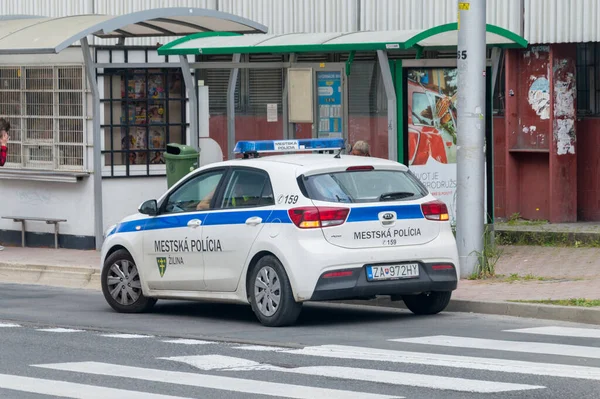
[310,262,458,301]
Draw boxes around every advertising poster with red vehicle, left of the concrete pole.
[407,68,487,224]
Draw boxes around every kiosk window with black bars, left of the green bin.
[98,67,189,177]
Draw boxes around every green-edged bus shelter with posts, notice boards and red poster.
[158,23,528,227]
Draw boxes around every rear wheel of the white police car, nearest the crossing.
[248,255,302,327]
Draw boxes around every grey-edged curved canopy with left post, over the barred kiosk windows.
[0,7,267,249]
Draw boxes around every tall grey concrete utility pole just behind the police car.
[456,0,486,277]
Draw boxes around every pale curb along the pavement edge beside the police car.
[0,263,600,325]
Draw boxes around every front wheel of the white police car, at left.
[100,249,156,313]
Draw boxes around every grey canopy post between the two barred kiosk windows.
[81,37,104,250]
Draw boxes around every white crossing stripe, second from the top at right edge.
[389,335,600,359]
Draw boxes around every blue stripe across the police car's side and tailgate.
[108,205,423,235]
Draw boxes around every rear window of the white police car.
[299,170,428,203]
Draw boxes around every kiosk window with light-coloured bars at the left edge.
[0,65,87,172]
